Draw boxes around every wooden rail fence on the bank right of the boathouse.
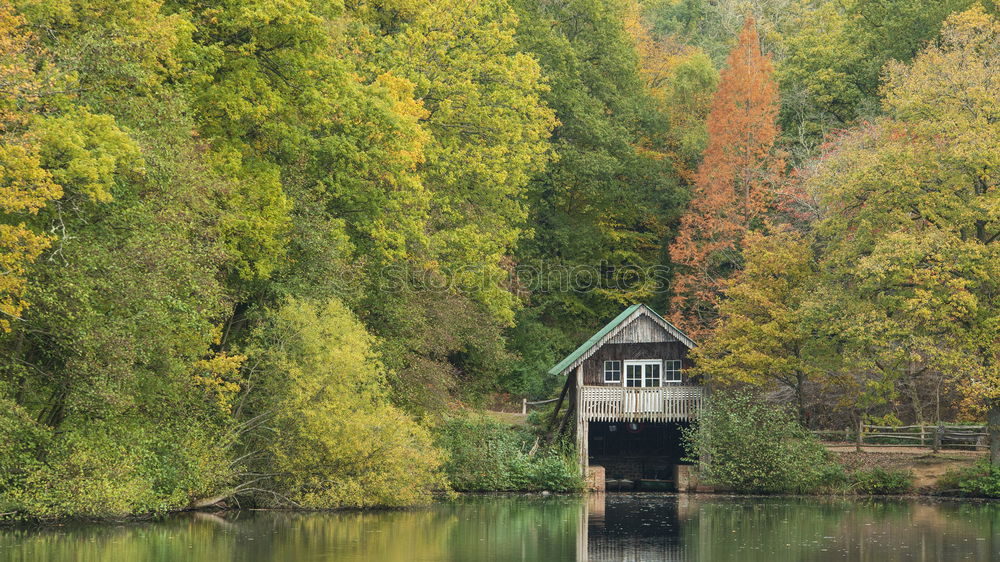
[813,423,989,451]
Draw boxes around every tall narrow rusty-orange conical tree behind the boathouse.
[670,18,783,337]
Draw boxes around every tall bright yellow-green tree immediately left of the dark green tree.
[370,0,555,323]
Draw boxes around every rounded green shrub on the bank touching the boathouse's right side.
[684,392,843,493]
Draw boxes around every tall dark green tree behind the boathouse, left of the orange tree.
[511,0,684,394]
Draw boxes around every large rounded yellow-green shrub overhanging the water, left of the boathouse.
[238,300,446,508]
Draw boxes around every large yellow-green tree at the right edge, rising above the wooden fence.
[807,7,1000,463]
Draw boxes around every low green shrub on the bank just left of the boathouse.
[434,416,583,492]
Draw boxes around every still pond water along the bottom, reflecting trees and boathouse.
[0,494,1000,562]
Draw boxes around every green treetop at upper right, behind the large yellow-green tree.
[773,0,997,153]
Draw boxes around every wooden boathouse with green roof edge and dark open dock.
[549,304,705,489]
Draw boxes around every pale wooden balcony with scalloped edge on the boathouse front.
[580,385,705,422]
